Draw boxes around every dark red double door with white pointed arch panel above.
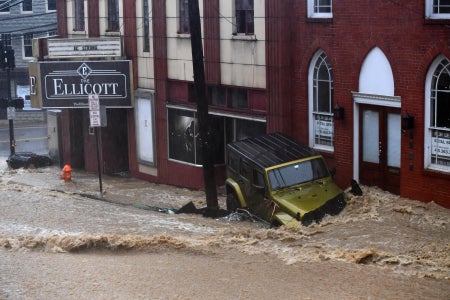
[353,48,401,194]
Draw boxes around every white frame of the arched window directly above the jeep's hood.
[308,50,334,152]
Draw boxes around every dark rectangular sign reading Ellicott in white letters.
[29,60,133,108]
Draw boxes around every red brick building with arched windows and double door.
[282,0,450,207]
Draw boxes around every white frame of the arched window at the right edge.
[424,55,450,173]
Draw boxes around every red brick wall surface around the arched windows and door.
[286,0,450,207]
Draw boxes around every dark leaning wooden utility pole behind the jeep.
[188,0,219,211]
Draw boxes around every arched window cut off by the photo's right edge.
[424,56,450,173]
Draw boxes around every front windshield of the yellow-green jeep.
[267,157,330,191]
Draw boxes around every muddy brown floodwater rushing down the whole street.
[0,167,450,299]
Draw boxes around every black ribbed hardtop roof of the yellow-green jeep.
[227,133,318,169]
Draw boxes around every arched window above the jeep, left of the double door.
[309,51,334,151]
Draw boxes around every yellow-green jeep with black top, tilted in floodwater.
[226,133,347,226]
